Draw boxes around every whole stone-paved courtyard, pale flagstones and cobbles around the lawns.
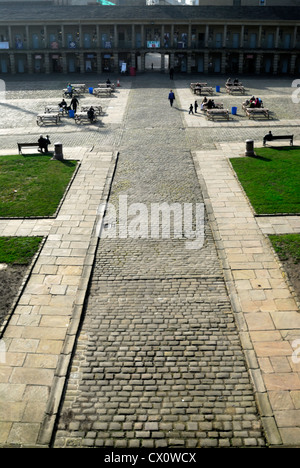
[0,73,300,449]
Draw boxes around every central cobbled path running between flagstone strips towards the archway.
[53,77,265,448]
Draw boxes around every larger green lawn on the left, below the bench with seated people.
[0,155,77,218]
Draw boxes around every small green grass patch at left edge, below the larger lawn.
[0,237,43,265]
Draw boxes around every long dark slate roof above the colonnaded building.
[0,3,300,24]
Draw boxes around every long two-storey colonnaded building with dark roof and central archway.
[0,1,300,77]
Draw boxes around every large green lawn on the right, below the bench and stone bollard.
[230,147,300,214]
